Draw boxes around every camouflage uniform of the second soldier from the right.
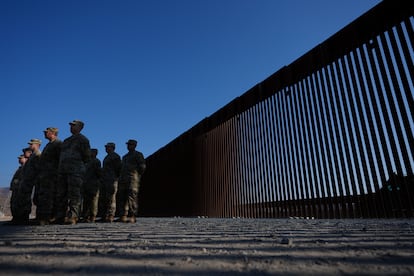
[101,148,121,219]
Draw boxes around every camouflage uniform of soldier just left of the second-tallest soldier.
[13,140,41,223]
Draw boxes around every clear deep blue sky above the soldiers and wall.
[0,0,380,187]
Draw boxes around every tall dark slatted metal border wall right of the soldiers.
[139,0,414,218]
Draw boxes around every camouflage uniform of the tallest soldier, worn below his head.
[55,133,90,223]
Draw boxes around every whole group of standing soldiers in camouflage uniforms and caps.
[6,120,146,225]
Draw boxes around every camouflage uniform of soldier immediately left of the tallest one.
[36,136,62,221]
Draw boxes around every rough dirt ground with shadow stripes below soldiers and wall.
[0,218,414,275]
